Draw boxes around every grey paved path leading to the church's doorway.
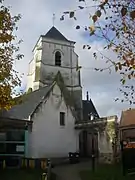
[53,161,91,180]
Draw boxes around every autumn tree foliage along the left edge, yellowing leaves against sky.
[0,0,23,109]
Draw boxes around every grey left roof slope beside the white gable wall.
[0,86,51,120]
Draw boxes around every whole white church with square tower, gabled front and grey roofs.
[0,26,99,158]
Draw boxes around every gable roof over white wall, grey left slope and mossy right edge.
[0,71,77,120]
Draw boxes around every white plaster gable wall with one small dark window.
[29,85,79,158]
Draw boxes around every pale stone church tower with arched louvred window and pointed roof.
[27,26,82,119]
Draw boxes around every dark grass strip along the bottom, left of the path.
[0,169,55,180]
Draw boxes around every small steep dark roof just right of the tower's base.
[83,99,99,120]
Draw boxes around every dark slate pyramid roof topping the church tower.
[44,26,75,42]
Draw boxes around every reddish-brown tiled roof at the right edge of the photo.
[120,109,135,126]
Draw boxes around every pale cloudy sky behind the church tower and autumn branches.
[5,0,134,117]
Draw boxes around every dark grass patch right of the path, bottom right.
[80,165,135,180]
